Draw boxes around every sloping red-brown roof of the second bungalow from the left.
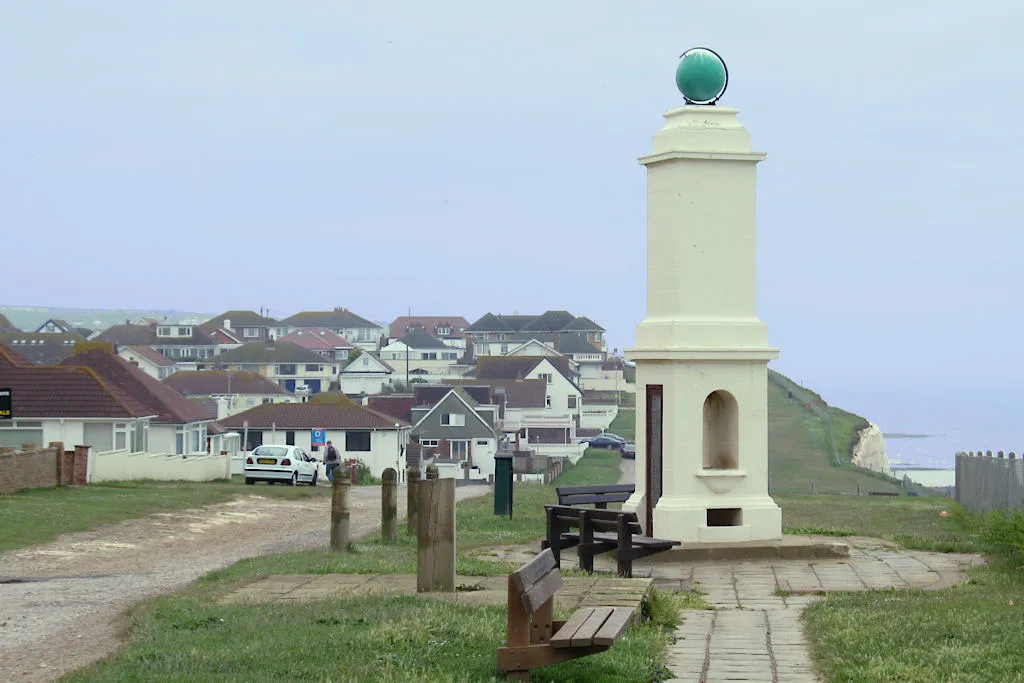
[60,349,216,423]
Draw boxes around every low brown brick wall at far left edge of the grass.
[0,443,89,494]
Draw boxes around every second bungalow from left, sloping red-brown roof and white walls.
[60,348,216,456]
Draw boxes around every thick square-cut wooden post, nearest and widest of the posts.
[416,475,455,593]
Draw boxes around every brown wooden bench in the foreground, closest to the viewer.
[498,550,636,681]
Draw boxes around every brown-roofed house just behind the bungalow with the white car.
[164,370,300,420]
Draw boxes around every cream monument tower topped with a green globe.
[624,48,782,543]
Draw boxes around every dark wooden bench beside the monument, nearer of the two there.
[542,505,680,578]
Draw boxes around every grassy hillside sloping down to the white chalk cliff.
[608,373,900,494]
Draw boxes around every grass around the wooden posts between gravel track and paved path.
[68,450,699,681]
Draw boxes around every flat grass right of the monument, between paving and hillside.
[774,496,985,553]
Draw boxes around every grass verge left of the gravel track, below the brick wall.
[0,477,331,552]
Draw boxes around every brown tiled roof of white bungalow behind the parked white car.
[220,403,409,430]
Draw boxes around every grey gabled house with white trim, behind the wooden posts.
[413,387,501,480]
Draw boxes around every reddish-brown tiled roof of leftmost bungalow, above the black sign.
[0,366,154,419]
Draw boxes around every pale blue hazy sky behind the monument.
[0,0,1024,430]
